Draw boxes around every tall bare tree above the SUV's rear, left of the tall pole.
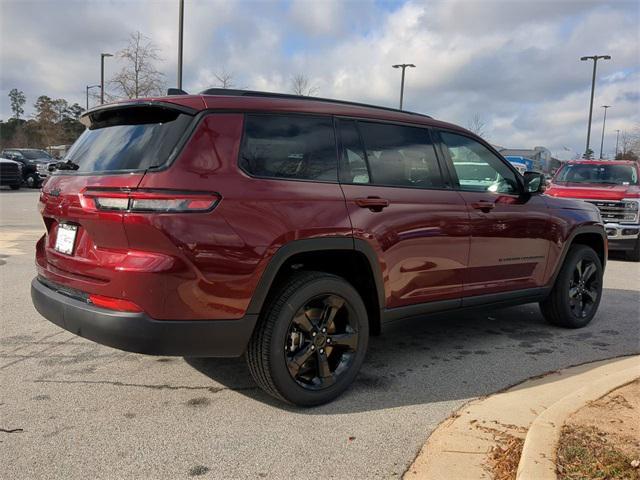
[109,32,165,98]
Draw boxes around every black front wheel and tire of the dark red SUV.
[540,245,603,328]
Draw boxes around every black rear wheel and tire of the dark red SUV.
[246,272,369,407]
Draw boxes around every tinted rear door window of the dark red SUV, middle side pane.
[358,122,444,188]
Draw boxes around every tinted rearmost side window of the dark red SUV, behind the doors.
[240,115,338,182]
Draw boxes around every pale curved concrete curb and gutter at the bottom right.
[404,355,640,480]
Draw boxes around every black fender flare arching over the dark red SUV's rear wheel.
[246,237,385,314]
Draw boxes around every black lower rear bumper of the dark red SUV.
[31,278,258,357]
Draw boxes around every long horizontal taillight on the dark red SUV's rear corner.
[80,189,220,213]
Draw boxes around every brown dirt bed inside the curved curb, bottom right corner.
[558,379,640,480]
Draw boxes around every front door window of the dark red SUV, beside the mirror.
[440,132,519,193]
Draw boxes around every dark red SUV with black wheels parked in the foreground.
[31,90,607,405]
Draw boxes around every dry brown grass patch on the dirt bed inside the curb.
[557,425,640,480]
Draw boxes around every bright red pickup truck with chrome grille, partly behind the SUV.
[546,160,640,262]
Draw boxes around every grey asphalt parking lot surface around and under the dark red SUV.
[0,189,640,479]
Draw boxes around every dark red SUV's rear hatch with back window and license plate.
[36,102,195,297]
